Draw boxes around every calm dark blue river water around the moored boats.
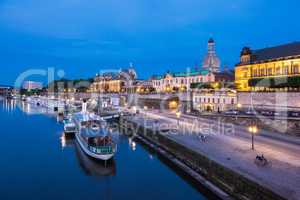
[0,101,217,200]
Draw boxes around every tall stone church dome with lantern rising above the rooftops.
[202,38,221,72]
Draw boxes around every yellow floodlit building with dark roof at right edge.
[235,42,300,92]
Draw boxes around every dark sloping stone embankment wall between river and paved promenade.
[121,119,284,200]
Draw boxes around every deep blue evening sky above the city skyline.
[0,0,300,84]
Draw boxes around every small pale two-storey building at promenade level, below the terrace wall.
[192,89,237,112]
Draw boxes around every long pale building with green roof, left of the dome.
[152,70,215,92]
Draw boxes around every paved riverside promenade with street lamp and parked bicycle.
[128,111,300,200]
